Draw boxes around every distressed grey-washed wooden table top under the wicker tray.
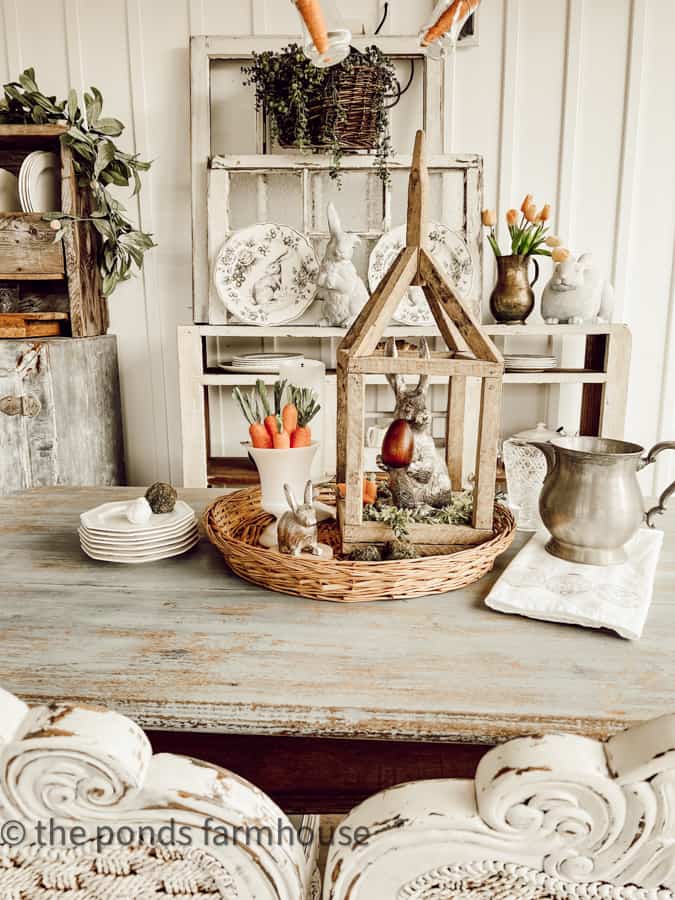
[0,488,675,743]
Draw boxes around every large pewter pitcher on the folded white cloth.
[532,437,675,566]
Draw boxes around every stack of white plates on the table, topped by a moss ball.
[77,500,199,563]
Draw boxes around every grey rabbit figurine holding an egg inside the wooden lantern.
[378,338,452,509]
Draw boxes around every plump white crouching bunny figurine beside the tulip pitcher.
[541,253,614,325]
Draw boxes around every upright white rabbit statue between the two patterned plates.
[316,203,369,328]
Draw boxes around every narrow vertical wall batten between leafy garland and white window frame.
[126,0,173,480]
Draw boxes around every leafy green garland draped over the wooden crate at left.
[0,69,155,296]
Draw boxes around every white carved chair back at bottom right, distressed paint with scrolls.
[323,716,675,900]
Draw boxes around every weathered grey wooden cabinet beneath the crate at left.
[0,335,124,494]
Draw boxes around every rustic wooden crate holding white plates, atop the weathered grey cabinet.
[0,125,108,337]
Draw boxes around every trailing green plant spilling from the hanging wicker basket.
[242,44,398,183]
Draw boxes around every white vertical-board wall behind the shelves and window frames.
[0,0,675,492]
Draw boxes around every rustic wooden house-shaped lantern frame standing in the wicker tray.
[337,131,504,553]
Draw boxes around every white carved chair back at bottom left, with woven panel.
[0,689,318,900]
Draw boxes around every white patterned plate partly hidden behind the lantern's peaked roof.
[368,224,473,325]
